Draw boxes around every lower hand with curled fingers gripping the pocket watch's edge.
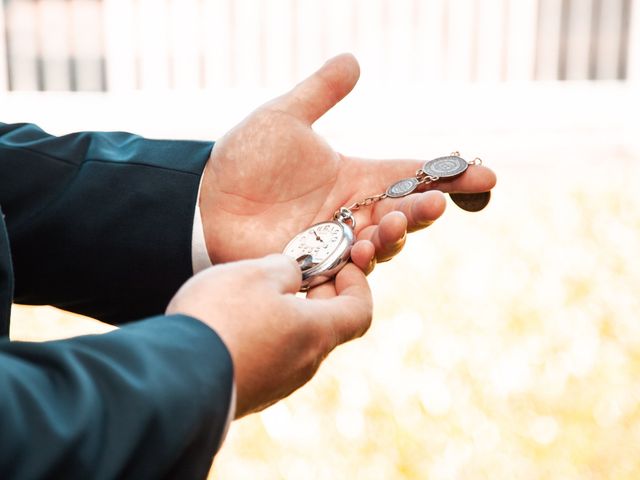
[167,255,372,417]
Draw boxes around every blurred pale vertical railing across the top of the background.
[0,0,640,91]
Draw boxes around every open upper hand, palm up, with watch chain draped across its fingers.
[200,54,495,270]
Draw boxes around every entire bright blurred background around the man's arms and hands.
[5,0,640,480]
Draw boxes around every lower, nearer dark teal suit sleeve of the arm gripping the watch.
[0,315,232,479]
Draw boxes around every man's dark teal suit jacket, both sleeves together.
[0,124,233,479]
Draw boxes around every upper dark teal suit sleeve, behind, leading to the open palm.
[0,123,212,323]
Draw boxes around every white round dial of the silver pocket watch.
[284,222,343,264]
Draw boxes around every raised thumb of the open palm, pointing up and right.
[274,53,360,125]
